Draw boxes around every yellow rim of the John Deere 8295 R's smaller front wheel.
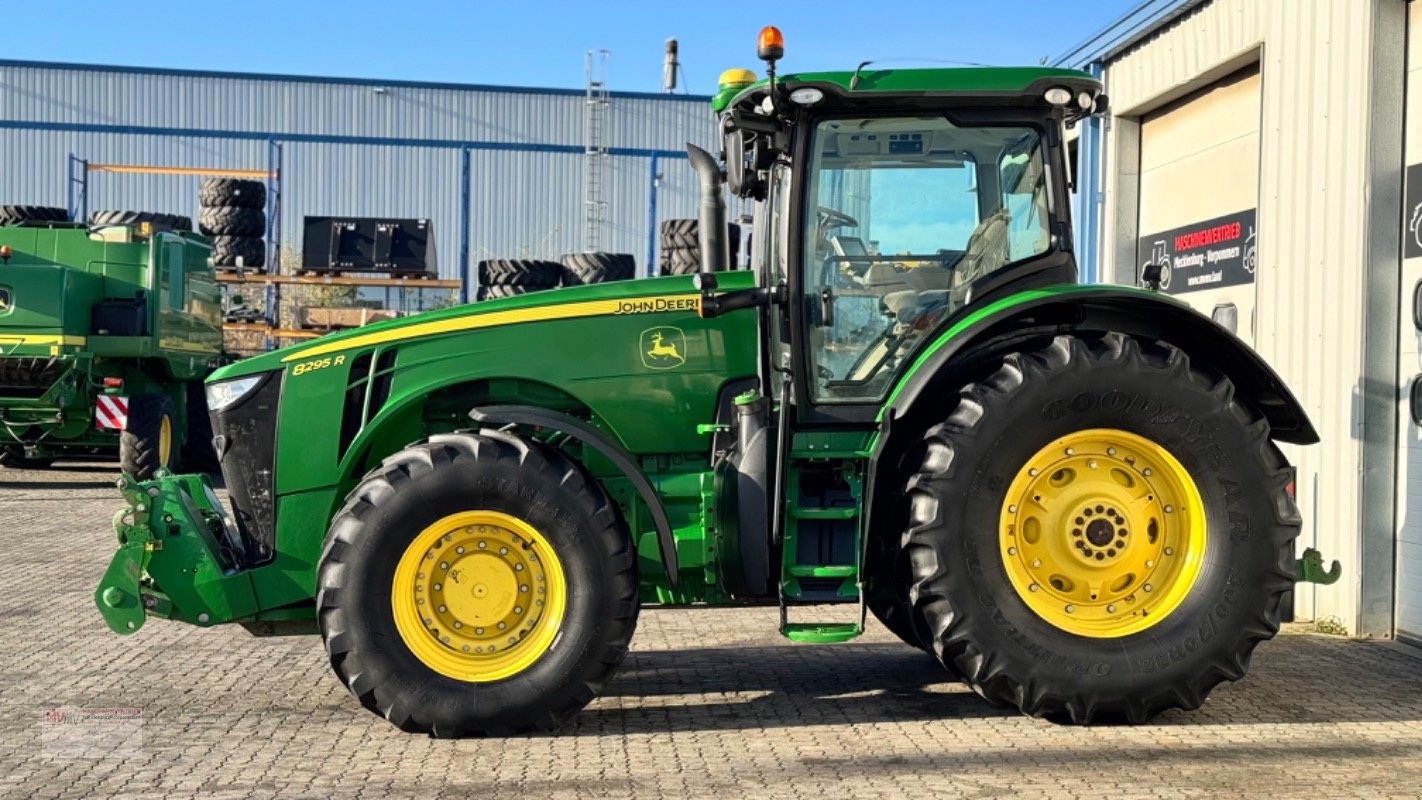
[391,512,567,682]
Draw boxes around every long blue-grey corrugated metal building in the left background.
[0,60,715,289]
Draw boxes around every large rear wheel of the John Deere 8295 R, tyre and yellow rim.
[903,334,1301,723]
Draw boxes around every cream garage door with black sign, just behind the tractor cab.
[1136,65,1261,344]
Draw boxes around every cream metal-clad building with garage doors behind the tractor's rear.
[1058,0,1422,641]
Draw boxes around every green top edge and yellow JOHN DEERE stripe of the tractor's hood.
[208,271,755,382]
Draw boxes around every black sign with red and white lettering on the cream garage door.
[1136,209,1258,294]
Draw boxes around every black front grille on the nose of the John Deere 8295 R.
[212,372,282,566]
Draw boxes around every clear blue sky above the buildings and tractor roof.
[0,0,1140,94]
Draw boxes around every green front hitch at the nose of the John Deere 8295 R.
[94,470,257,634]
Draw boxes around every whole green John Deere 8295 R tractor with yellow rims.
[95,28,1317,736]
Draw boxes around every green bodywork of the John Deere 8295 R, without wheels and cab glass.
[95,68,1317,650]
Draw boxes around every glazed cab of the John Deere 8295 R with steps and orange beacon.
[693,28,1106,639]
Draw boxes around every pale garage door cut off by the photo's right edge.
[1395,4,1422,644]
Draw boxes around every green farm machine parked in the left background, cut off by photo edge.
[0,206,223,479]
